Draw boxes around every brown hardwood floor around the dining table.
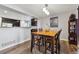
[0,40,77,54]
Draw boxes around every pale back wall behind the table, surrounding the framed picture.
[40,10,78,39]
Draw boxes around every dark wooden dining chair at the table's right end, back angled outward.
[45,30,62,54]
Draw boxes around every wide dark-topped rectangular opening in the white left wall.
[1,17,20,27]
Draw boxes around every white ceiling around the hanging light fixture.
[0,4,78,18]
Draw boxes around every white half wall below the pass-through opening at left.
[0,27,29,50]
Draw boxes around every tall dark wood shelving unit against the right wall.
[68,14,77,45]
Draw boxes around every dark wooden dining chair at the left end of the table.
[31,29,41,52]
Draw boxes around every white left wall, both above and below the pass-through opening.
[0,6,31,50]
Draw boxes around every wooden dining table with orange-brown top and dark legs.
[31,31,58,54]
